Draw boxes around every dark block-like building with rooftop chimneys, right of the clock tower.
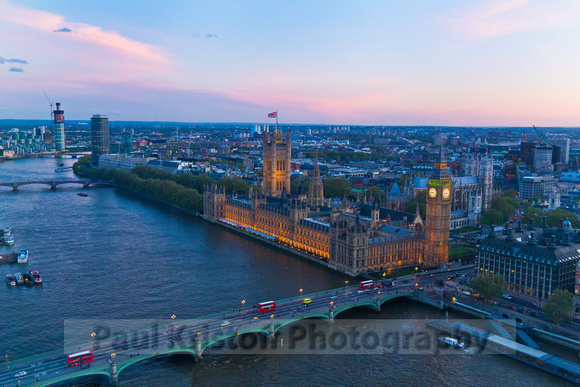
[477,218,580,299]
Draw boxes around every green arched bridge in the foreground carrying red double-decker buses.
[0,280,447,386]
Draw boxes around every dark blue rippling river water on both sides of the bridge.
[0,159,563,386]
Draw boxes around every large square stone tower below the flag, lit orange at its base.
[262,131,292,197]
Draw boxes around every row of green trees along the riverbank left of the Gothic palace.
[73,156,249,212]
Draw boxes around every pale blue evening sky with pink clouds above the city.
[0,0,580,127]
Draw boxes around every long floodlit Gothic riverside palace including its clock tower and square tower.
[203,132,451,275]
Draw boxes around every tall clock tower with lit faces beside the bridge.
[424,149,452,267]
